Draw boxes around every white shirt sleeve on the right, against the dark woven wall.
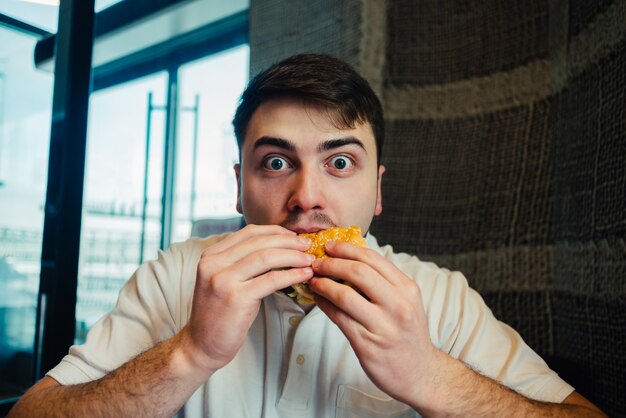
[398,250,574,402]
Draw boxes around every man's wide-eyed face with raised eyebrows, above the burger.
[235,99,385,233]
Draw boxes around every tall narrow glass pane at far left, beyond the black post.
[0,27,53,399]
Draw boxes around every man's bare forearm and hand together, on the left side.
[10,225,313,418]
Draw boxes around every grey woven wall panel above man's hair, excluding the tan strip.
[250,0,362,74]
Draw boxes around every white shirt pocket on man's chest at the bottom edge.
[335,385,420,418]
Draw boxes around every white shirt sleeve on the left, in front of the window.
[47,240,197,385]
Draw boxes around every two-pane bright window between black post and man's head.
[75,44,248,343]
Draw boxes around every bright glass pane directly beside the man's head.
[173,45,249,241]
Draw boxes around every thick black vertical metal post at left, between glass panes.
[34,0,95,380]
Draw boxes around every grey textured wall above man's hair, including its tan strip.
[245,0,387,93]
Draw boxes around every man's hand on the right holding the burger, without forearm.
[310,242,440,404]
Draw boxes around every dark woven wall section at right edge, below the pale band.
[551,42,626,240]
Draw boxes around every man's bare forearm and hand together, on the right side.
[310,243,605,417]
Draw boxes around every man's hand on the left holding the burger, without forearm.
[181,225,314,371]
